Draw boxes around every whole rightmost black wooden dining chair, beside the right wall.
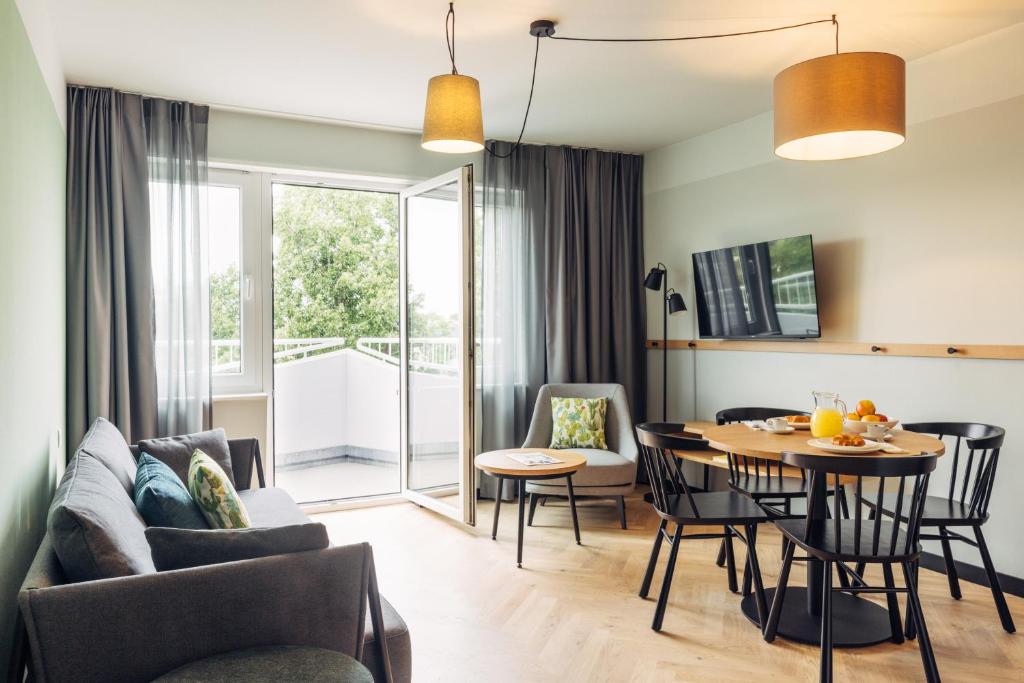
[865,422,1017,634]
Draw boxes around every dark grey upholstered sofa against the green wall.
[10,423,412,682]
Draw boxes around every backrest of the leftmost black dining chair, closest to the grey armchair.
[636,422,711,517]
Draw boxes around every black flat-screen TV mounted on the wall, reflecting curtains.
[693,234,821,339]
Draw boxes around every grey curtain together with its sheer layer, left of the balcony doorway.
[67,85,209,446]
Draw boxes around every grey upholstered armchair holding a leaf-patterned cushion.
[523,384,638,528]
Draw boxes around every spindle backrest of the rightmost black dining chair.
[903,422,1006,517]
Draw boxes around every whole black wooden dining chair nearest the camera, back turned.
[764,453,939,683]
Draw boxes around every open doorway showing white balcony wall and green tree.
[272,181,400,504]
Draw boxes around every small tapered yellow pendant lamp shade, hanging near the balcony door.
[422,74,483,154]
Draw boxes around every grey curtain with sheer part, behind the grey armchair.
[479,142,646,497]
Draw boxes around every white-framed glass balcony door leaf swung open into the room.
[399,166,476,524]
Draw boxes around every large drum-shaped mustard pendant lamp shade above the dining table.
[774,52,906,161]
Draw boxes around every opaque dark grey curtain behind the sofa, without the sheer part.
[67,86,157,446]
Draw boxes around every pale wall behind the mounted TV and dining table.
[644,25,1024,577]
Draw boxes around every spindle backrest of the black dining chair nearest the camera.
[782,452,938,556]
